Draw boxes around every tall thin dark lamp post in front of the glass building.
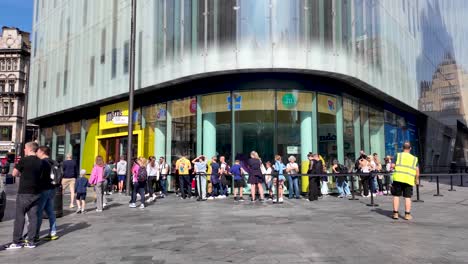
[126,0,137,195]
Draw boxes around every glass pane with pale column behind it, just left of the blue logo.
[201,93,232,160]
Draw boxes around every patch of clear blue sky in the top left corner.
[0,0,33,32]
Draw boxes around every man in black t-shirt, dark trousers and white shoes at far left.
[6,142,46,250]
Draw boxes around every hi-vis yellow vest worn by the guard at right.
[393,152,418,186]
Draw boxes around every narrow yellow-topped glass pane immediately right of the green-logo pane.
[317,94,338,168]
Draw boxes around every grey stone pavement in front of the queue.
[0,177,468,264]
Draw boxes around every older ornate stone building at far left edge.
[0,27,31,156]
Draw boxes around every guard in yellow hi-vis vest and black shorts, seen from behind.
[392,142,419,220]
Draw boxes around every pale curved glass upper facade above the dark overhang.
[30,0,468,118]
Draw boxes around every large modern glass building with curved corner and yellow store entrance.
[28,0,468,186]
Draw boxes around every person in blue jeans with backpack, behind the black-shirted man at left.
[34,146,58,242]
